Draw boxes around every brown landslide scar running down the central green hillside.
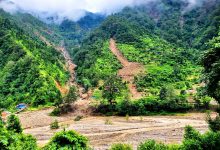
[110,39,144,99]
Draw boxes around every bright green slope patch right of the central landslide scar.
[118,37,201,95]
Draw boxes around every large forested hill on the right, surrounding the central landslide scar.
[74,0,220,99]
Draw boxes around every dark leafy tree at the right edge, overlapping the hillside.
[201,29,220,132]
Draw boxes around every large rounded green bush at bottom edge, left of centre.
[43,131,88,150]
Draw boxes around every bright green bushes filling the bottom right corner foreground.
[116,126,220,150]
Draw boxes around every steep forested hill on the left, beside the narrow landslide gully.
[0,15,69,108]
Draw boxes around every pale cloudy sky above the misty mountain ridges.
[0,0,201,21]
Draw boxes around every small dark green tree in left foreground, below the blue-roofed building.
[6,114,22,133]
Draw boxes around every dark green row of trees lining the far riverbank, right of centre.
[96,97,193,116]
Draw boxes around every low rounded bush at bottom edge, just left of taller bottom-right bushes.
[138,140,168,150]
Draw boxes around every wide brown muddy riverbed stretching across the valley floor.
[19,110,213,150]
